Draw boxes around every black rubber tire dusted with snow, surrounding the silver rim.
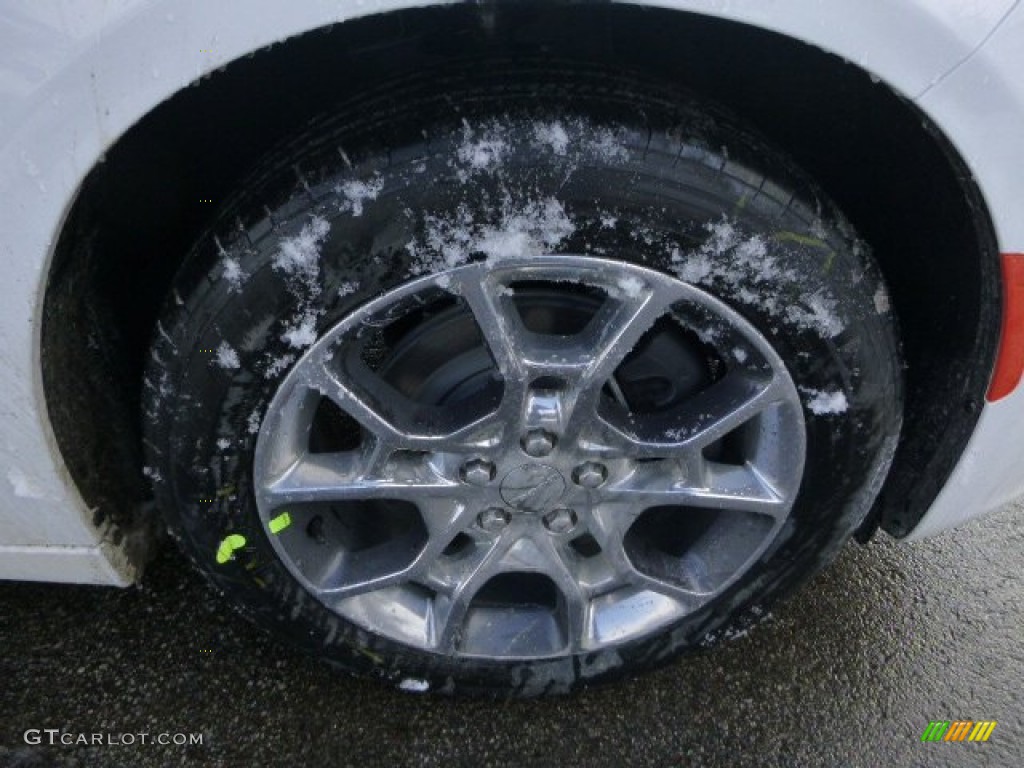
[144,67,901,695]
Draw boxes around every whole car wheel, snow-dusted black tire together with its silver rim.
[144,67,901,695]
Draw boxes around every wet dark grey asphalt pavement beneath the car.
[0,506,1024,768]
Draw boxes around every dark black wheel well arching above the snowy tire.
[42,3,1000,557]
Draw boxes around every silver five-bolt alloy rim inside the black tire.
[253,255,805,659]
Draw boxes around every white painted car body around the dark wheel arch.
[0,0,1024,585]
